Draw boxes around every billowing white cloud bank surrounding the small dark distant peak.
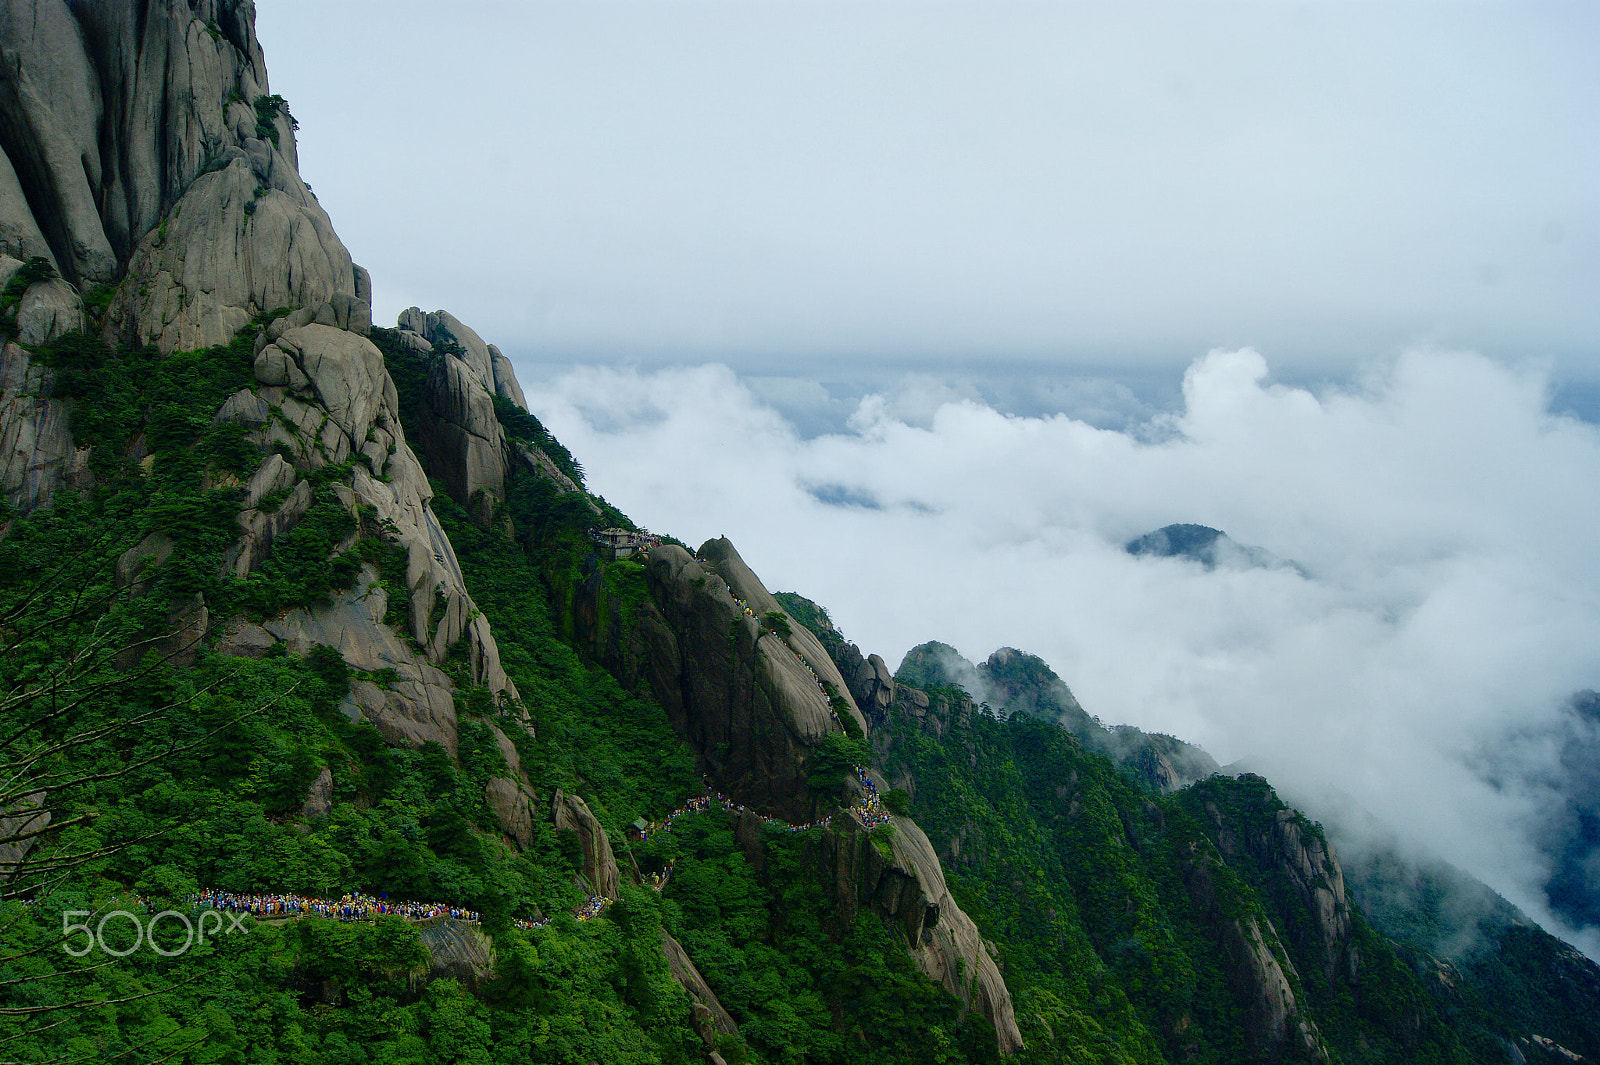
[530,349,1600,955]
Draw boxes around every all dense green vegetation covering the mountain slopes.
[0,300,1595,1065]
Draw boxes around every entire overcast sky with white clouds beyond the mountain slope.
[258,0,1600,955]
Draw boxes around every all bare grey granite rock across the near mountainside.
[0,0,1019,1049]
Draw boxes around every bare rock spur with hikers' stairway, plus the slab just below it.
[592,539,1022,1054]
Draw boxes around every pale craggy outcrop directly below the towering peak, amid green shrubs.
[218,311,515,710]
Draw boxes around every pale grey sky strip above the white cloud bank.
[258,0,1600,413]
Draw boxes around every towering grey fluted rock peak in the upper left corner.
[0,0,355,350]
